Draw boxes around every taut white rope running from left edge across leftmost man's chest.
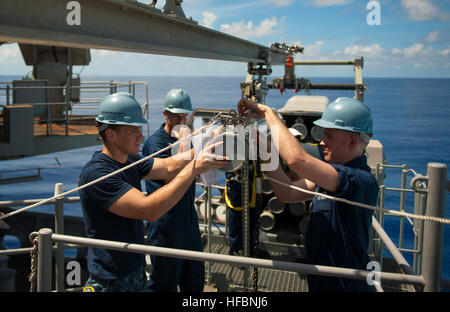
[0,121,217,220]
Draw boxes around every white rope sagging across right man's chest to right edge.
[264,175,450,224]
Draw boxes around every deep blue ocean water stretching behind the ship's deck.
[0,76,450,279]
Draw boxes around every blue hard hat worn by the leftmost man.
[95,92,148,127]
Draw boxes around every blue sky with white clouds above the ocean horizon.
[0,0,450,77]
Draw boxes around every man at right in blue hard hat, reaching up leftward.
[238,98,378,292]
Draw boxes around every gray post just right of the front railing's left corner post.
[55,183,64,291]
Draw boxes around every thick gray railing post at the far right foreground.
[422,163,447,292]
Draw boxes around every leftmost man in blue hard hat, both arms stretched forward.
[79,92,226,291]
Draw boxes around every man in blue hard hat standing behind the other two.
[142,89,205,292]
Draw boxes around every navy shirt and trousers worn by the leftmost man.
[79,151,153,292]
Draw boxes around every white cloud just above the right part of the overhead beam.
[220,17,281,39]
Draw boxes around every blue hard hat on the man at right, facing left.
[314,97,373,134]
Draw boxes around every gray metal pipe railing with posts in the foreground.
[0,163,450,291]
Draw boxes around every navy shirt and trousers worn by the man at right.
[305,156,378,292]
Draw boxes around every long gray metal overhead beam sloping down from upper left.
[0,0,287,65]
